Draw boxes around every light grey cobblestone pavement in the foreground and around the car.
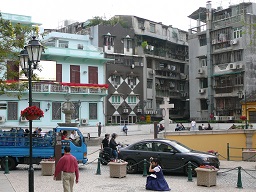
[0,135,256,192]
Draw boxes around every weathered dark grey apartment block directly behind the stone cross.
[115,15,189,120]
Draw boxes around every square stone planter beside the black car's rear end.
[108,162,128,178]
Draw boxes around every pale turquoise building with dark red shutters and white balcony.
[0,12,108,128]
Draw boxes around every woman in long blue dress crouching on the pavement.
[146,158,171,191]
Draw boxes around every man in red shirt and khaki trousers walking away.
[53,146,79,192]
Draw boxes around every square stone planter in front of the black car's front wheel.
[195,167,218,187]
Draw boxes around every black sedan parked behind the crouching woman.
[118,139,220,176]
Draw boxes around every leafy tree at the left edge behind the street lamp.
[0,13,38,98]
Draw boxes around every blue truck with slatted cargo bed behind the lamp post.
[0,127,88,170]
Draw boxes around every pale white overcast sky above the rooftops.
[0,0,252,30]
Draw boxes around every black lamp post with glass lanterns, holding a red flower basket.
[20,36,43,192]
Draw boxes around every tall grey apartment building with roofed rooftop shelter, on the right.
[188,2,256,122]
